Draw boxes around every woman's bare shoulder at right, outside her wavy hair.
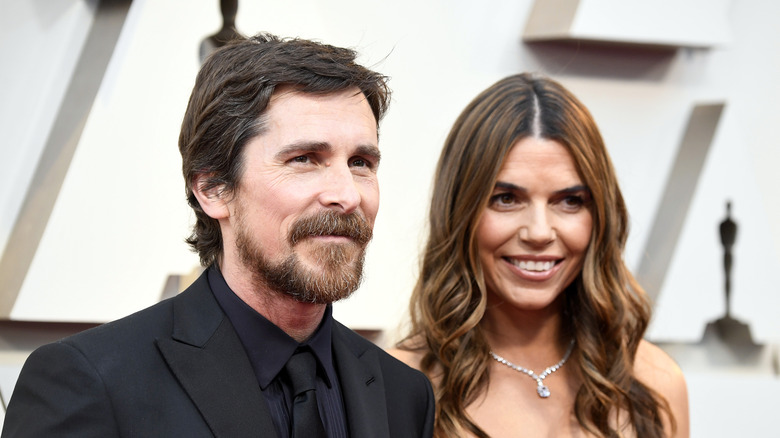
[634,340,689,437]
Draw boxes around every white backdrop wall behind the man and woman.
[0,0,780,436]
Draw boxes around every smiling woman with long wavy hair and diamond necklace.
[393,74,688,438]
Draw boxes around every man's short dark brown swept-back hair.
[179,33,390,266]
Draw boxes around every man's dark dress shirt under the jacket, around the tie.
[208,265,349,438]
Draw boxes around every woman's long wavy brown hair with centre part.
[406,74,674,437]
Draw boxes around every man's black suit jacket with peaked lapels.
[2,274,434,438]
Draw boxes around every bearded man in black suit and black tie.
[2,35,434,438]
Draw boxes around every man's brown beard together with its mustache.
[236,209,372,304]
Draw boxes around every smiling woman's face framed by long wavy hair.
[476,137,593,310]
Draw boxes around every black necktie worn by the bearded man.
[284,349,327,438]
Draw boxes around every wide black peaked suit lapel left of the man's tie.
[157,271,275,438]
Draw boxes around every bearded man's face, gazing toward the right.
[225,89,379,303]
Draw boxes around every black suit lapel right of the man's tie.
[333,321,390,438]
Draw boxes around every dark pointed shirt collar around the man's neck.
[208,265,336,389]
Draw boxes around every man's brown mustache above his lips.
[290,211,373,245]
